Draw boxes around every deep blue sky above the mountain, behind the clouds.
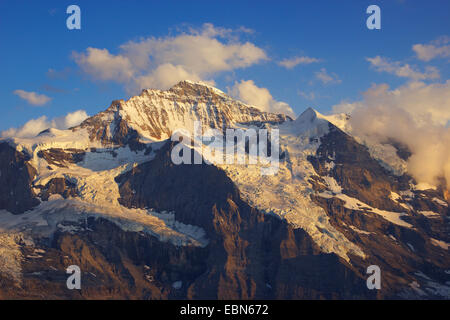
[0,0,450,131]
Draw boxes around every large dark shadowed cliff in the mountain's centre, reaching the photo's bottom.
[117,144,373,299]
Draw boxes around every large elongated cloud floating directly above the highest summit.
[73,24,268,93]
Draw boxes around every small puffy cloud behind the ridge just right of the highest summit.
[229,80,295,118]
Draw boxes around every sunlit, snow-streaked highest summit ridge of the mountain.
[75,80,290,145]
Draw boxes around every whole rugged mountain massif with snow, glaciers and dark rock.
[0,81,450,299]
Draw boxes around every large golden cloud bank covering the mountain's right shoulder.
[334,80,450,188]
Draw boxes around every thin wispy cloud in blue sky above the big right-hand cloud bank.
[367,56,440,81]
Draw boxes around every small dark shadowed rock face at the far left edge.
[0,143,39,214]
